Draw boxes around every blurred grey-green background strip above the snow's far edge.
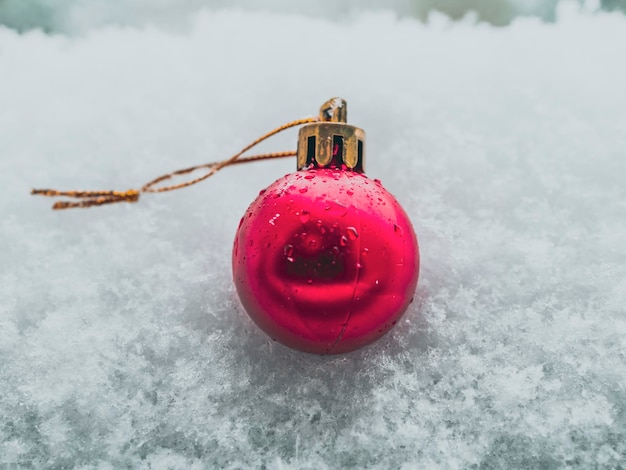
[0,0,626,34]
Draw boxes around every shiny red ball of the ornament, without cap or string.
[233,169,419,354]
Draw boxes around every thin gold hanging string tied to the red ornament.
[31,117,312,210]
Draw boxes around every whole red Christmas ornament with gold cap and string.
[32,98,419,354]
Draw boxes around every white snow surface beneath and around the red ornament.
[0,4,626,470]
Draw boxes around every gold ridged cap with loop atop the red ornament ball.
[297,98,365,173]
